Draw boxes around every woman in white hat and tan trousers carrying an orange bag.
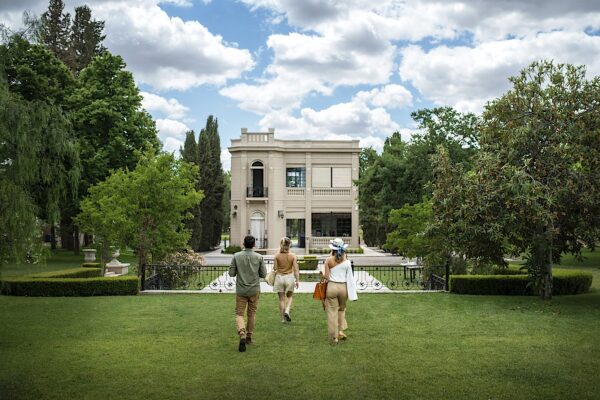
[323,238,358,344]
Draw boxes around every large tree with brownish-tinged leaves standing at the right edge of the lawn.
[433,61,600,299]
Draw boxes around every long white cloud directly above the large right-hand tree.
[399,31,600,112]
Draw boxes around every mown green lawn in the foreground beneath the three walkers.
[0,250,600,400]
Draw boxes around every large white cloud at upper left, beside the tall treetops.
[0,0,254,90]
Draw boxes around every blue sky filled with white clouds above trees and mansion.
[0,0,600,169]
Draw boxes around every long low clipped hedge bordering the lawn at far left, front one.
[0,276,140,297]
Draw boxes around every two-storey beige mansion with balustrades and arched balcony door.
[229,128,361,254]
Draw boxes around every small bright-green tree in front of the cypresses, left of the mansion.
[77,150,203,272]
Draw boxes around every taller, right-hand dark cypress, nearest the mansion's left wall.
[198,115,225,250]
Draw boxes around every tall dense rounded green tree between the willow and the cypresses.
[61,52,161,251]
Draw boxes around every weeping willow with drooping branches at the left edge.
[0,53,80,260]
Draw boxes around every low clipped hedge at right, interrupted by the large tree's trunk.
[450,269,592,296]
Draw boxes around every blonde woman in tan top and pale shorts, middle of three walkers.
[273,237,300,322]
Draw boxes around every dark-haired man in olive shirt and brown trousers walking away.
[229,236,267,352]
